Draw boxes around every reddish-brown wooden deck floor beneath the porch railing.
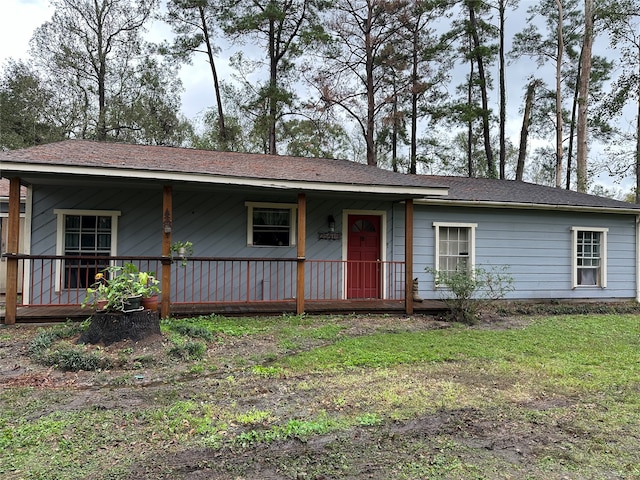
[0,300,446,323]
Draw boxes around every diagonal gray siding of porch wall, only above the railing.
[31,186,393,260]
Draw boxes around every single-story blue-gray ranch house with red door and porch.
[0,140,640,323]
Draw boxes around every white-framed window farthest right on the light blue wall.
[571,227,608,288]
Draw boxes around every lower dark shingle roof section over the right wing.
[422,175,640,209]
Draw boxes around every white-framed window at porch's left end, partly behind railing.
[54,210,120,290]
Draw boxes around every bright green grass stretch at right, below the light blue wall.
[279,315,640,389]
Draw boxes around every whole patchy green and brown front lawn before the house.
[0,314,640,480]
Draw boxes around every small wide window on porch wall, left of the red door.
[245,202,298,247]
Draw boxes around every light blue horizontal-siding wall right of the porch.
[394,205,636,299]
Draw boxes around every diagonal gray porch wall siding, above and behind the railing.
[31,186,393,301]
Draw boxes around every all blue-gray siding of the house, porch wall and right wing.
[31,182,636,299]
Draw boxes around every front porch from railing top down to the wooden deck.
[0,255,444,323]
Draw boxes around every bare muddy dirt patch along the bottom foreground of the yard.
[138,410,568,480]
